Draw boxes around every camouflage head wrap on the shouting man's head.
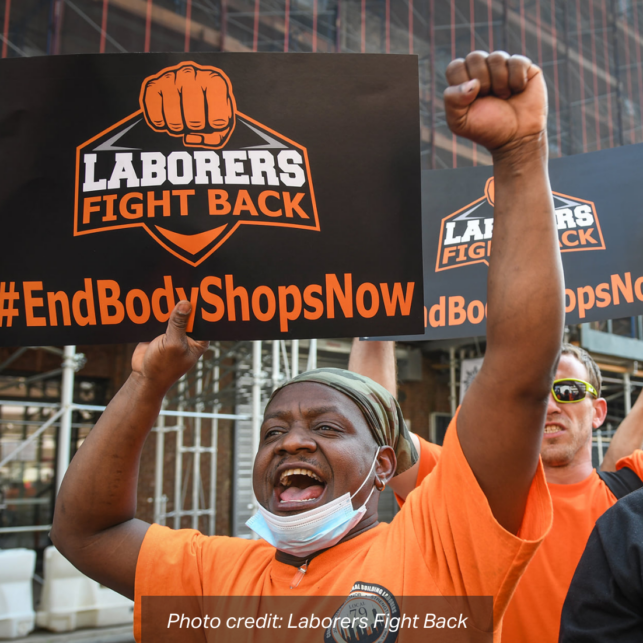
[268,368,418,475]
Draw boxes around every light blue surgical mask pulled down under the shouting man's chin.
[246,449,379,558]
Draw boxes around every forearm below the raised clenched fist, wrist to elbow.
[485,133,564,400]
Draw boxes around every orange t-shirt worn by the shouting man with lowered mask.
[134,420,552,643]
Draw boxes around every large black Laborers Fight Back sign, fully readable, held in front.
[0,54,423,345]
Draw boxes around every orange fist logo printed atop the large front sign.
[140,62,236,149]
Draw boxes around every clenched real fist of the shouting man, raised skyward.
[444,51,547,151]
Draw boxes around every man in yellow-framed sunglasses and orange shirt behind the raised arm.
[349,342,643,643]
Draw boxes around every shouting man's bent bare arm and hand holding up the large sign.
[51,301,207,598]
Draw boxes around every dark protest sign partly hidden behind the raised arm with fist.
[374,145,643,341]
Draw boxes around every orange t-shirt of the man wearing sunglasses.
[408,438,643,643]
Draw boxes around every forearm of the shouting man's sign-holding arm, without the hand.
[52,374,163,548]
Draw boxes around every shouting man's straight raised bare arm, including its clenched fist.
[444,52,564,533]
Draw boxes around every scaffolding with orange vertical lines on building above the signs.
[0,0,643,169]
